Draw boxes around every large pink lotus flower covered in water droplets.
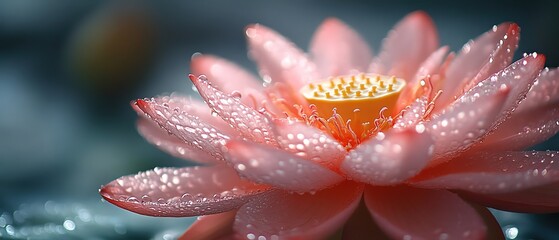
[100,12,559,239]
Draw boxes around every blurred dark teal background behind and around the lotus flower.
[0,0,559,239]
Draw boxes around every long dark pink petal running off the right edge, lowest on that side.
[413,152,559,212]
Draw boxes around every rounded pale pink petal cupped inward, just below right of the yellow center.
[341,129,433,185]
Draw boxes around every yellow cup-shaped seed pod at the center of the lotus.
[300,74,406,134]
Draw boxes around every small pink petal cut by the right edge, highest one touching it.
[511,65,559,111]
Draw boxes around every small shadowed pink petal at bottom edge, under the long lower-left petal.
[179,211,237,240]
